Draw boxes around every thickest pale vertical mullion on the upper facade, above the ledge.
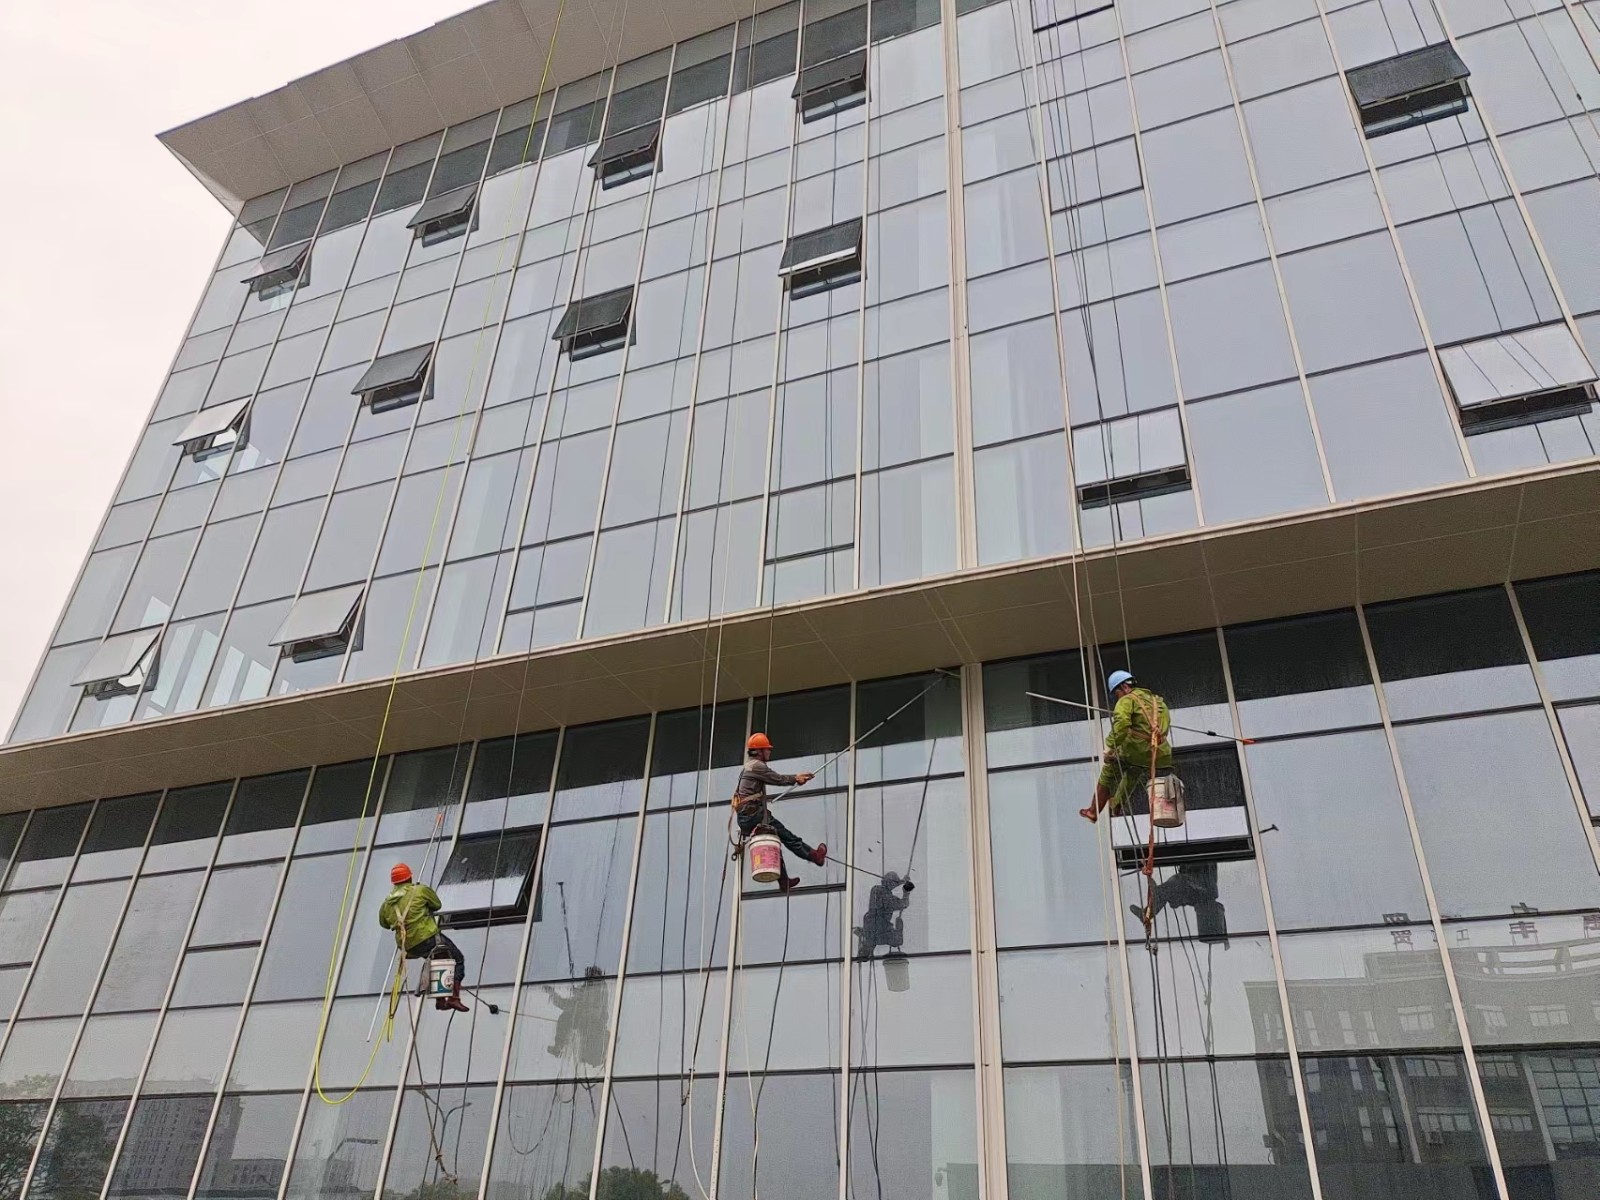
[940,0,979,572]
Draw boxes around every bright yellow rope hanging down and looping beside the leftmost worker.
[312,0,566,1106]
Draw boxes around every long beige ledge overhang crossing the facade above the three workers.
[0,461,1600,811]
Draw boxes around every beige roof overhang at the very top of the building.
[160,0,793,214]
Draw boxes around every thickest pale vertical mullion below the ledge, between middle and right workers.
[962,664,1004,1200]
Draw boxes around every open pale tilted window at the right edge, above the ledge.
[1438,325,1595,434]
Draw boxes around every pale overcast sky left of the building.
[0,0,475,738]
